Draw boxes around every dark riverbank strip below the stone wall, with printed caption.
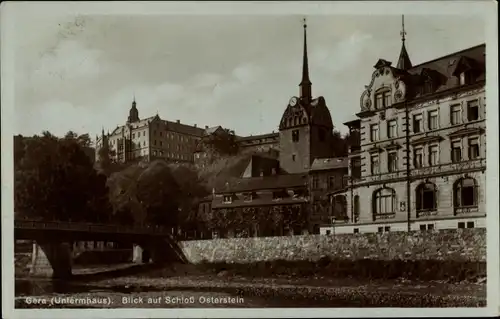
[16,273,486,308]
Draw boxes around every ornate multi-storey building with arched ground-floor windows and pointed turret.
[321,20,486,234]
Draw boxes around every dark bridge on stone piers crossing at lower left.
[14,220,187,279]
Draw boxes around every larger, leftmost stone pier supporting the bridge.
[30,242,72,279]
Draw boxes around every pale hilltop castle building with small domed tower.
[96,99,208,163]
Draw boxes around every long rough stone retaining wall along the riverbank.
[180,228,486,263]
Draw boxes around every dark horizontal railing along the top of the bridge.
[14,220,171,235]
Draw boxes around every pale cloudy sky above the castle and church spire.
[10,10,485,137]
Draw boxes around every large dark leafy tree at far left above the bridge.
[14,131,109,222]
